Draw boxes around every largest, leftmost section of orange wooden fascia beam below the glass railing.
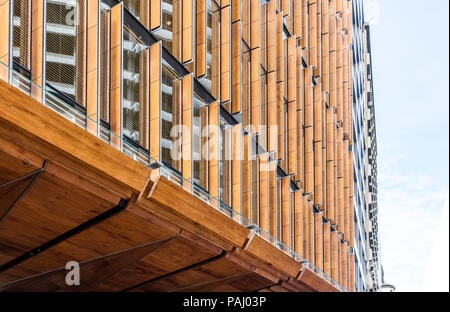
[0,81,150,198]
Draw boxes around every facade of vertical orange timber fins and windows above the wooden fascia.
[0,0,379,291]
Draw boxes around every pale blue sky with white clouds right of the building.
[364,0,449,292]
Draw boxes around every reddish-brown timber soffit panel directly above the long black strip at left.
[0,172,112,268]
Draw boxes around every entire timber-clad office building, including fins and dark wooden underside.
[0,0,378,291]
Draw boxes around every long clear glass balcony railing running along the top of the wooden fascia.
[0,61,348,292]
